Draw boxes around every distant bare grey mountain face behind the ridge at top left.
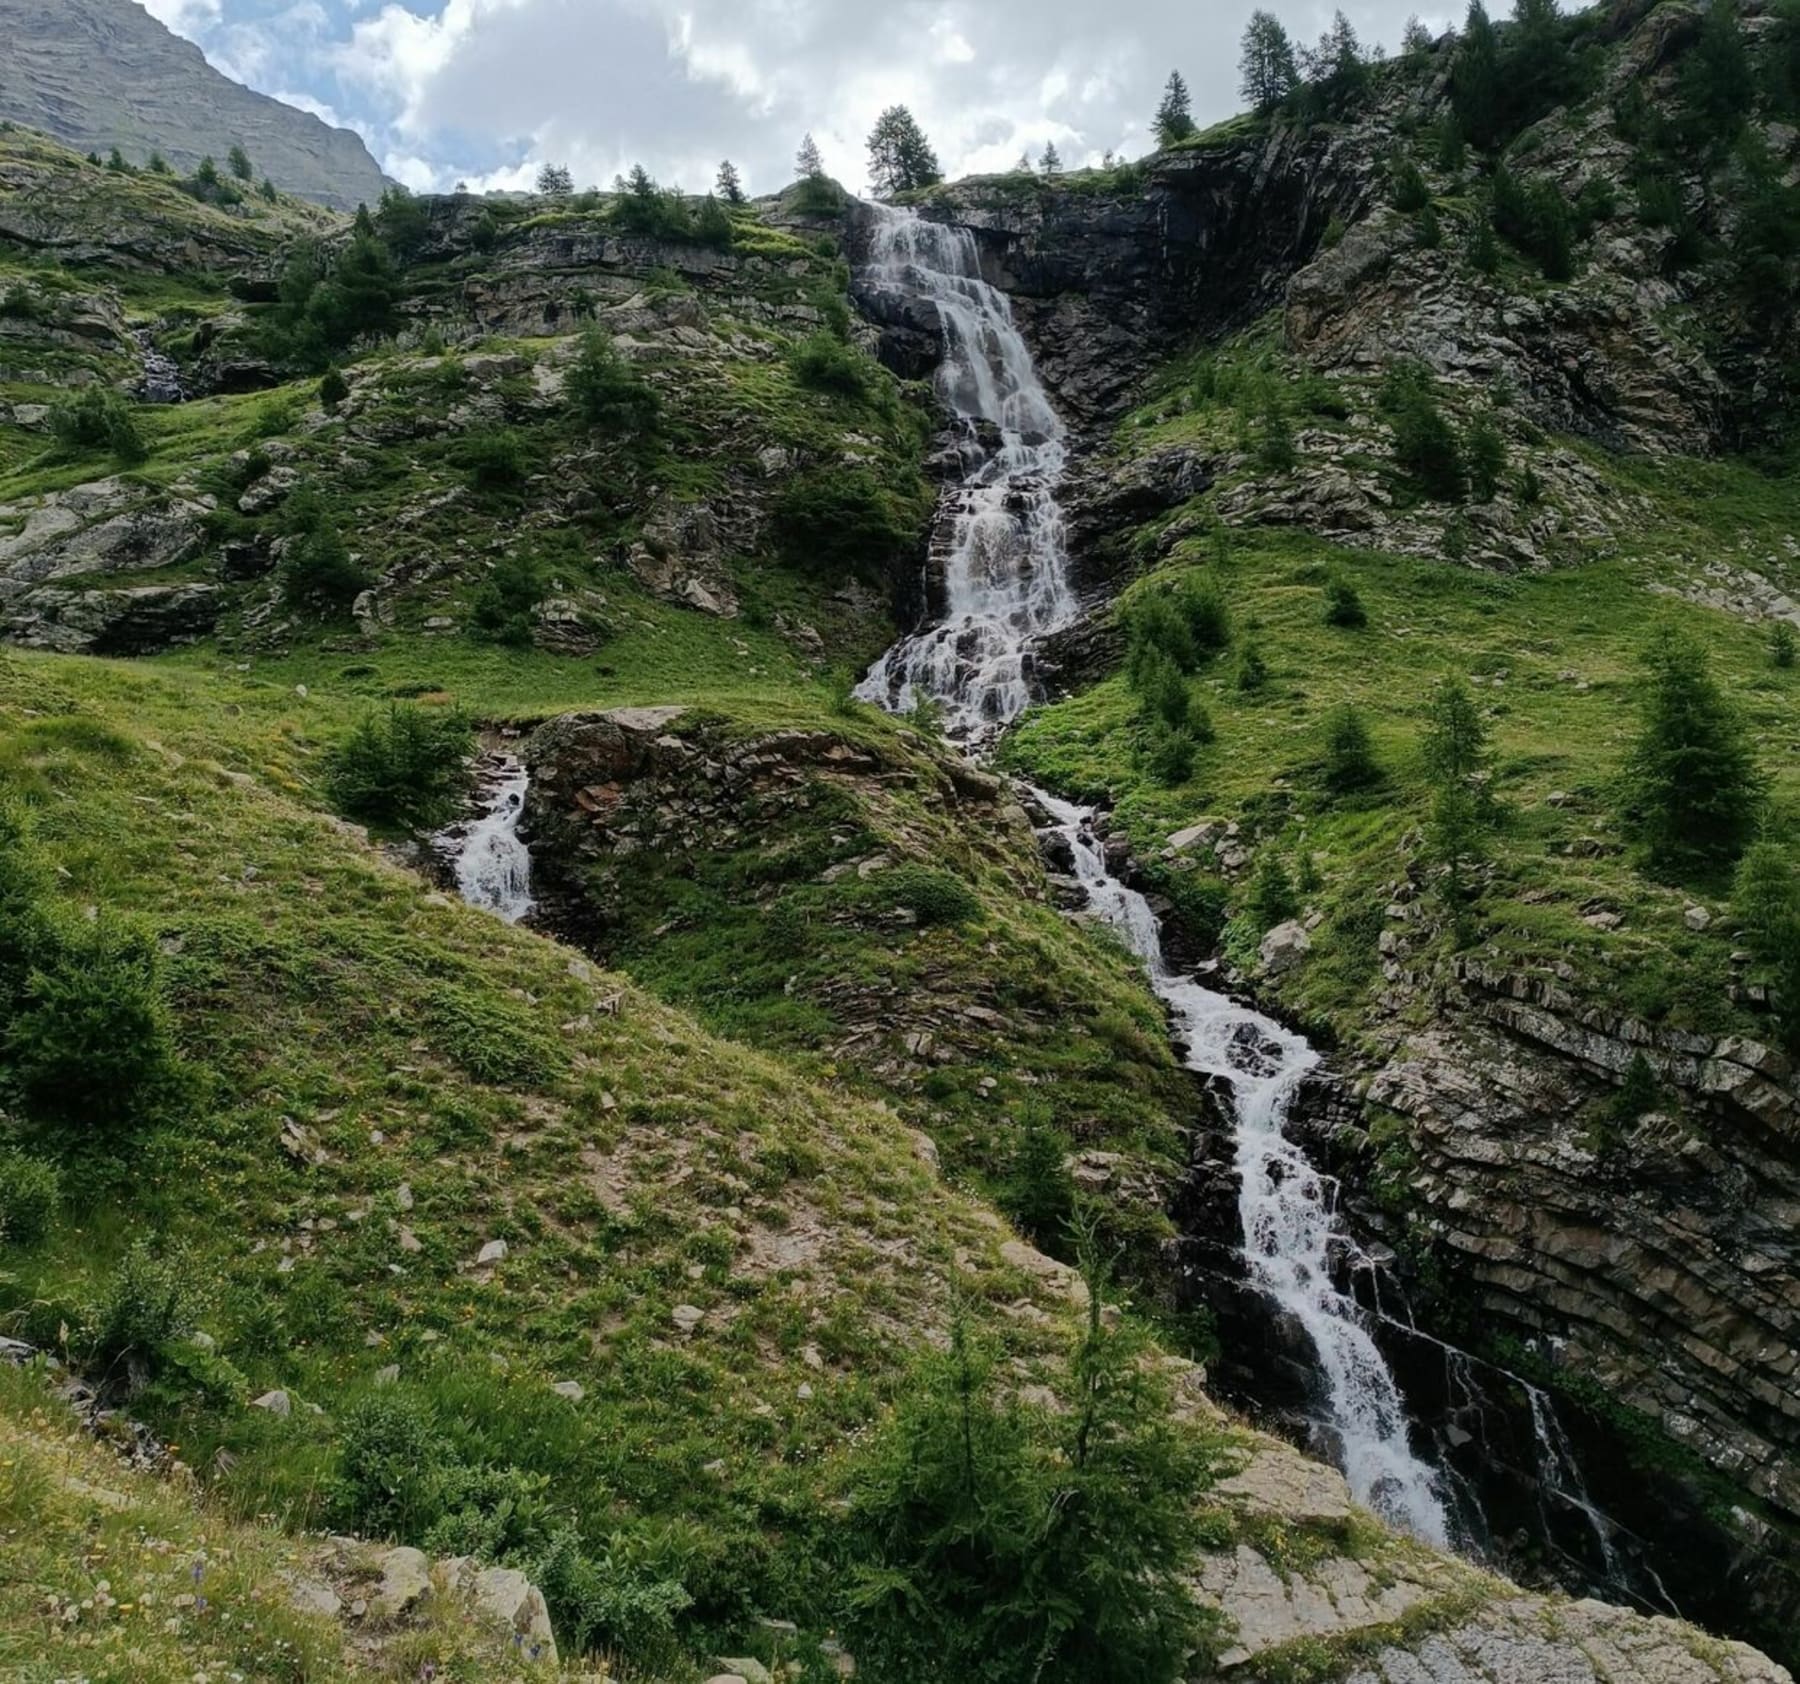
[0,0,387,211]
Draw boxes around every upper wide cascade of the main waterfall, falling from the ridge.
[857,205,1075,741]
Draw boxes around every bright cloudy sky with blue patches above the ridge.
[146,0,1449,193]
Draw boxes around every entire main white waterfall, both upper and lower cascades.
[857,207,1449,1544]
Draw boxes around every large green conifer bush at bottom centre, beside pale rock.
[842,1268,1211,1684]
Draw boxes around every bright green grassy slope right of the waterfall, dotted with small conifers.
[1010,329,1800,1036]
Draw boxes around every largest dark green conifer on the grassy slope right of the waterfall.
[1624,632,1764,874]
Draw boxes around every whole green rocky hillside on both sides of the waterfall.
[0,5,1800,1684]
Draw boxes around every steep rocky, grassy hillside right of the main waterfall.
[907,5,1800,1643]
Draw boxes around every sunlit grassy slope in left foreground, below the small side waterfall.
[0,644,1166,1648]
